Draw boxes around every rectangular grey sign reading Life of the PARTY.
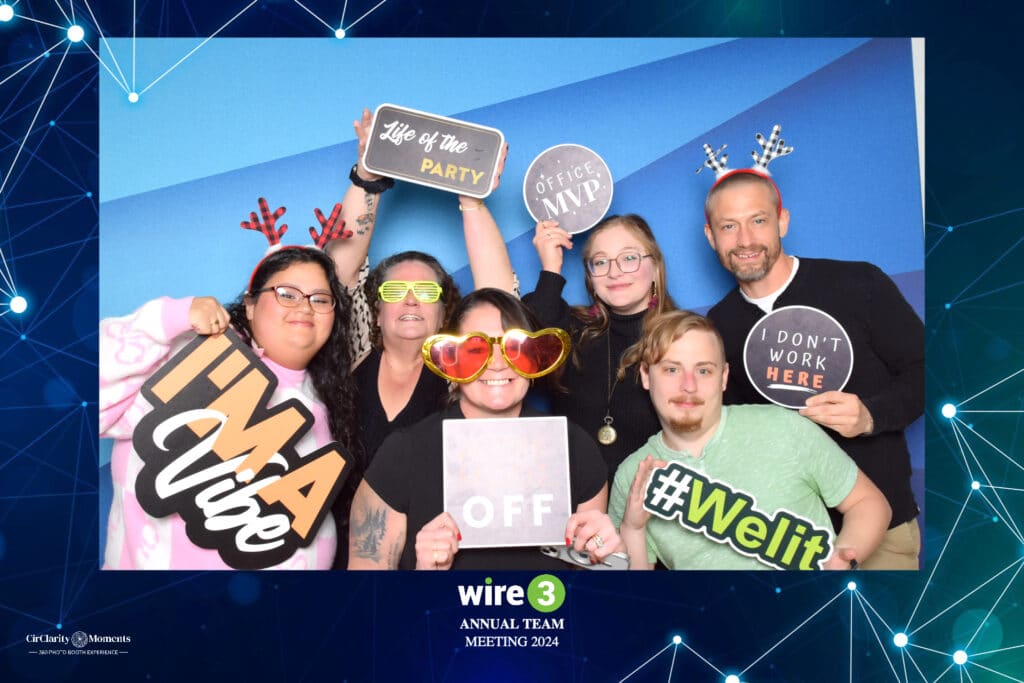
[362,104,505,199]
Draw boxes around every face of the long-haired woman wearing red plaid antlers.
[246,262,335,370]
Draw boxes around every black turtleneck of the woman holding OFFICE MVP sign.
[523,270,662,485]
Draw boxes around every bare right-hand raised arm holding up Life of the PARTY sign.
[459,144,519,295]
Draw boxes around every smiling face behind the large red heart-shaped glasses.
[457,303,529,418]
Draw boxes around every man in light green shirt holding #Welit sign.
[608,310,892,569]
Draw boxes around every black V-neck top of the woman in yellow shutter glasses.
[332,349,447,569]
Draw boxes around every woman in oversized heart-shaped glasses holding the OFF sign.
[348,289,621,569]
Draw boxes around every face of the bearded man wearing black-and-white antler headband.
[705,181,790,296]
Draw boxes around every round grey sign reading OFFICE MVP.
[522,144,613,233]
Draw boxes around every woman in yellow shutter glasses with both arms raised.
[327,110,518,568]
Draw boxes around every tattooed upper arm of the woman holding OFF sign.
[348,481,406,569]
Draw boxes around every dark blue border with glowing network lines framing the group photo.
[0,0,1024,682]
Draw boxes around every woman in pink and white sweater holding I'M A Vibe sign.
[99,247,355,569]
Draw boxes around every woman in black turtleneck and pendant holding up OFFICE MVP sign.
[523,214,676,481]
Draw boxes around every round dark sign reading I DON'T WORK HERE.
[743,306,853,408]
